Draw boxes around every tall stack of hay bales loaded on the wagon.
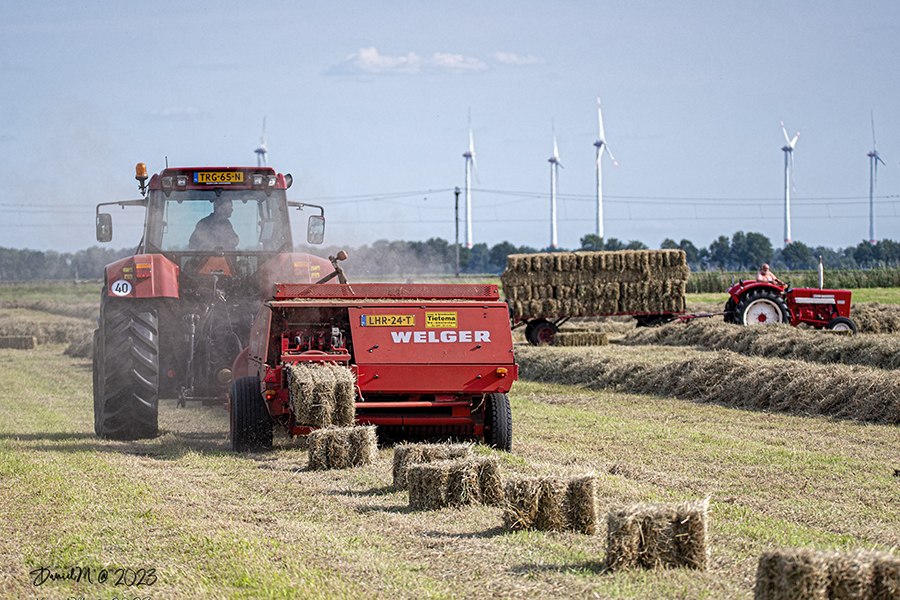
[500,250,690,319]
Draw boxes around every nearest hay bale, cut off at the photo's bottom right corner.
[754,548,900,600]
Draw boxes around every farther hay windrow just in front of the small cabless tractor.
[623,319,900,369]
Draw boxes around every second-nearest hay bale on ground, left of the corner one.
[606,500,709,570]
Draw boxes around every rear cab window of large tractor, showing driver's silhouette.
[148,190,290,252]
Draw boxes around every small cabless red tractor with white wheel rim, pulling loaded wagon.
[725,280,856,334]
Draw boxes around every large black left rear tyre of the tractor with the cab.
[94,299,159,440]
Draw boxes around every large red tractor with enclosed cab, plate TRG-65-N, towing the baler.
[93,163,332,439]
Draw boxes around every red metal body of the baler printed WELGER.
[247,284,518,435]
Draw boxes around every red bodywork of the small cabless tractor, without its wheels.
[728,281,852,328]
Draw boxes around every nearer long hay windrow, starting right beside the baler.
[516,346,900,425]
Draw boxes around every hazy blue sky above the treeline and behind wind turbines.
[0,0,900,251]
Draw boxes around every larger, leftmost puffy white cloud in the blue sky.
[327,46,488,75]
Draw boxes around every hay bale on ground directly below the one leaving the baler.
[307,425,378,471]
